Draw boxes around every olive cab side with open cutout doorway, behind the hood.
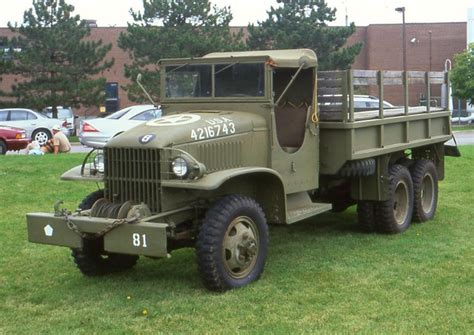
[271,69,319,194]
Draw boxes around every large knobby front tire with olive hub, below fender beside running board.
[196,195,268,291]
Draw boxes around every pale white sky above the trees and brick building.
[0,0,474,27]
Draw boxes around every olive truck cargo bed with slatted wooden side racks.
[318,71,452,174]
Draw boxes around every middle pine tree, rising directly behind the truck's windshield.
[119,0,244,102]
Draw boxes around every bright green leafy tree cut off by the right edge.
[449,43,474,105]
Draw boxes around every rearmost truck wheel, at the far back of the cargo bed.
[411,159,438,222]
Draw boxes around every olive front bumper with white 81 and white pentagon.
[26,213,168,257]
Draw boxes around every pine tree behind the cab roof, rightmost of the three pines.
[247,0,362,70]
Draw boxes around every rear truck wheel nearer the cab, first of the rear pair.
[375,164,413,234]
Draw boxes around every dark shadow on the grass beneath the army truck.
[62,209,368,294]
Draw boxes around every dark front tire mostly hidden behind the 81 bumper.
[71,190,138,276]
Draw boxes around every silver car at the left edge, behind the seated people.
[0,108,62,145]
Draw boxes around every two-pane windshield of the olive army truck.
[165,62,265,98]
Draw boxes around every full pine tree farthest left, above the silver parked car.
[9,0,113,117]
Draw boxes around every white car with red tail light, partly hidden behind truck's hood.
[79,105,161,148]
